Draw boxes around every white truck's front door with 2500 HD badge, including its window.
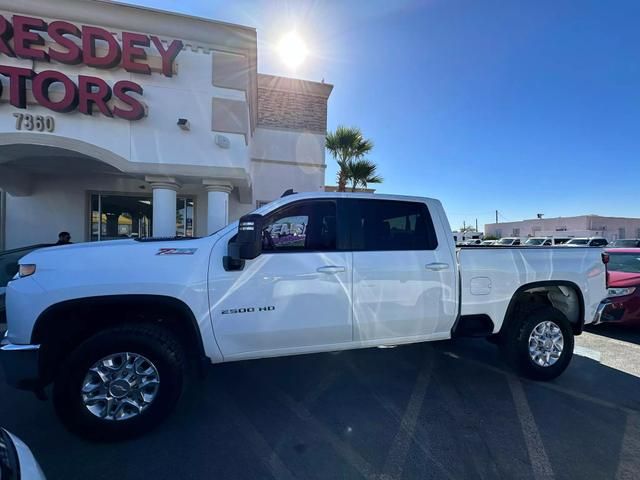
[210,199,353,358]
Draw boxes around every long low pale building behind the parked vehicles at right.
[484,215,640,241]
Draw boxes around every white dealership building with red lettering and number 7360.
[0,0,332,249]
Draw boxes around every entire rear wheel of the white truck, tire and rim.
[501,307,574,380]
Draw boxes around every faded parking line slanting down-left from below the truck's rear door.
[382,355,433,479]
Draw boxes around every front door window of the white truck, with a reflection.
[262,201,337,252]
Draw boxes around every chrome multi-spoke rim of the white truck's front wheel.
[82,352,160,420]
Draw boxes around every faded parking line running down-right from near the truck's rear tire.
[507,375,554,480]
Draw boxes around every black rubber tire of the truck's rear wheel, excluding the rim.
[500,307,574,380]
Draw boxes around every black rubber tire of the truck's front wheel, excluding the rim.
[53,325,187,441]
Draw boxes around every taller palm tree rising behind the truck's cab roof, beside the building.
[325,125,373,192]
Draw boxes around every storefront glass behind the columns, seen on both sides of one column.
[91,194,194,242]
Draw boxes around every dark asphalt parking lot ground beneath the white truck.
[0,328,640,480]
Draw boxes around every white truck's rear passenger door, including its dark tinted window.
[349,199,457,343]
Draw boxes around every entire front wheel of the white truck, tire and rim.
[53,325,186,440]
